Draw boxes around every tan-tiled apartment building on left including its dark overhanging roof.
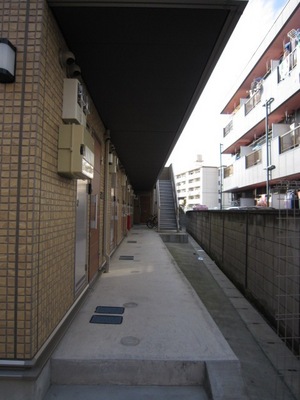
[0,0,247,400]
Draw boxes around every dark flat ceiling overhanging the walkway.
[48,0,247,192]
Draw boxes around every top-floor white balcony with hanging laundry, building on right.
[223,45,300,154]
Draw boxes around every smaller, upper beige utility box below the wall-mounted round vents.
[62,78,88,126]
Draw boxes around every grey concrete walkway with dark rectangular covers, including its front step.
[45,227,296,400]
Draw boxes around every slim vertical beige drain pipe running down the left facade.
[103,130,111,272]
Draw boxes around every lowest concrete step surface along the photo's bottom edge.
[44,385,208,400]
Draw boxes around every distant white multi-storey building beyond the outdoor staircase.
[175,155,218,210]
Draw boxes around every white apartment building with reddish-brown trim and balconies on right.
[222,0,300,208]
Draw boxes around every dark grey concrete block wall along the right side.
[186,210,300,353]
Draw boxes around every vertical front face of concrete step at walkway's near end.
[51,359,205,386]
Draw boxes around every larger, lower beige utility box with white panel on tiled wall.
[57,124,94,179]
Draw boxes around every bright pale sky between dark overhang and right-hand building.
[166,0,289,173]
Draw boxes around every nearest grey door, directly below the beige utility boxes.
[75,179,88,292]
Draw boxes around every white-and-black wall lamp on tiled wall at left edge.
[0,39,16,83]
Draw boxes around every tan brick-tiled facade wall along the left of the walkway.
[0,0,133,361]
